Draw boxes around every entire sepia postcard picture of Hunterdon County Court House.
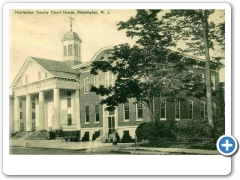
[9,9,225,155]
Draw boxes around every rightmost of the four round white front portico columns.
[53,89,60,130]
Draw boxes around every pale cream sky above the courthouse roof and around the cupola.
[9,9,225,83]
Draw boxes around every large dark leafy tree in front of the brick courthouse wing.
[91,10,204,121]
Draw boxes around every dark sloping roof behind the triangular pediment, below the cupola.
[30,57,78,75]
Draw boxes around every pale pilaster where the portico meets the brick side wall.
[73,90,81,130]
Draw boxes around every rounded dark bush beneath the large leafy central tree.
[136,121,175,142]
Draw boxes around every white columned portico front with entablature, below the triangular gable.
[13,77,80,132]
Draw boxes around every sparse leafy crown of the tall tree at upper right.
[163,9,225,56]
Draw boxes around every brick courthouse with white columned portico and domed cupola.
[10,26,223,140]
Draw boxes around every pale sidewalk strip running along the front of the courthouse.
[10,140,220,155]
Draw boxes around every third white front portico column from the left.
[38,91,45,130]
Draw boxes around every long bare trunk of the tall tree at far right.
[201,11,214,126]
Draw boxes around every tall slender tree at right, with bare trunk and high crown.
[164,10,225,126]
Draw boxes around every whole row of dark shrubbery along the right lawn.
[136,119,225,150]
